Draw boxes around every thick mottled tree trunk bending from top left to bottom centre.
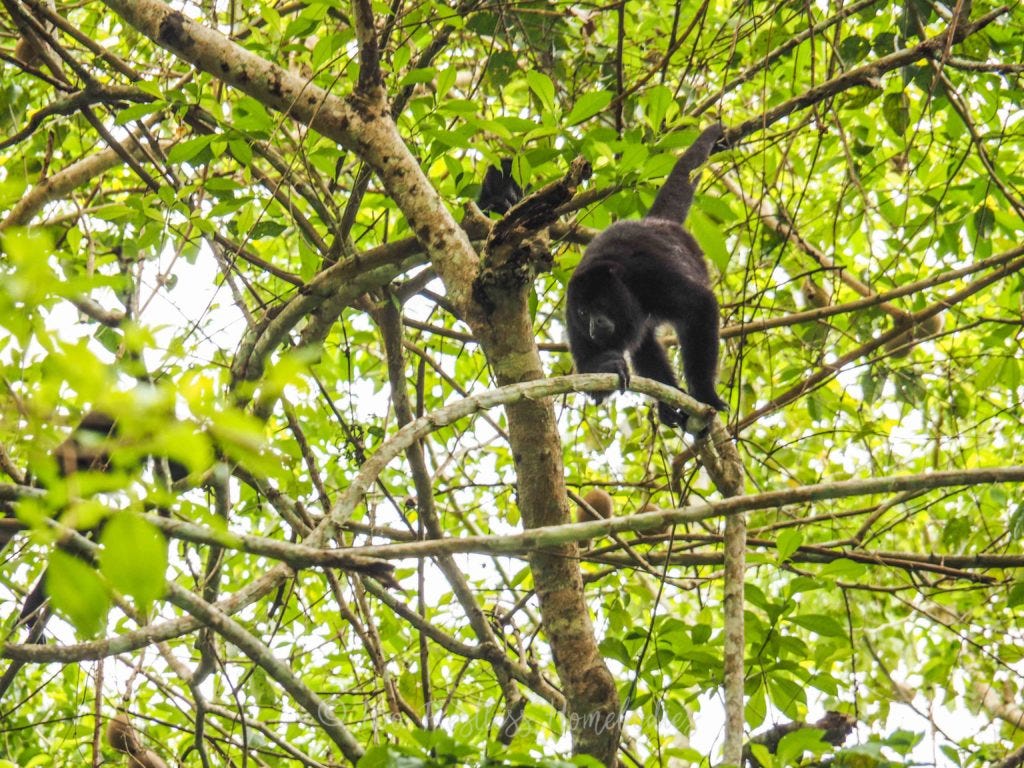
[104,0,618,766]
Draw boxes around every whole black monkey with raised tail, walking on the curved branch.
[567,125,728,429]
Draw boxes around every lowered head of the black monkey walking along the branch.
[567,261,645,348]
